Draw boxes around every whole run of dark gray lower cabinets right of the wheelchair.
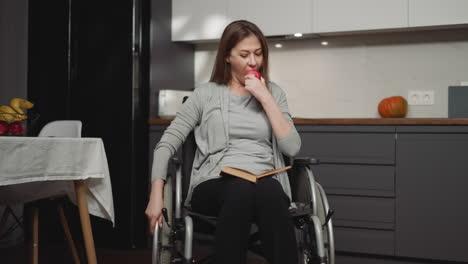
[297,125,468,264]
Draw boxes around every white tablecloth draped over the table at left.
[0,136,114,223]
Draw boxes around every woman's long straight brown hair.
[210,20,269,85]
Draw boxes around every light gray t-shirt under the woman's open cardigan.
[221,92,274,174]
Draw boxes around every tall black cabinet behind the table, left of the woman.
[28,0,150,247]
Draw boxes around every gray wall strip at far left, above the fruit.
[0,0,28,105]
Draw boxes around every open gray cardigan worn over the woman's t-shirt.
[152,82,301,206]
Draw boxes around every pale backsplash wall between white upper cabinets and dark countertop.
[195,29,468,118]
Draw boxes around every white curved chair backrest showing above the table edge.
[39,120,82,137]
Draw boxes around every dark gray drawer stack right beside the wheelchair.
[297,125,395,256]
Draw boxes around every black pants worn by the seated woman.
[191,175,297,264]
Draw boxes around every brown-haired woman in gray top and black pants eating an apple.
[146,20,301,264]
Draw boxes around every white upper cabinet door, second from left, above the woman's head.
[227,0,312,36]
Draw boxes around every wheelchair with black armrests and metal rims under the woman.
[152,132,335,264]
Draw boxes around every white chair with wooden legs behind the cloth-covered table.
[32,120,82,264]
